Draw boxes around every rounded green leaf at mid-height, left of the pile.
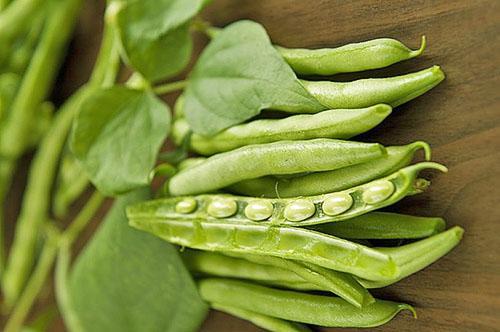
[71,86,170,195]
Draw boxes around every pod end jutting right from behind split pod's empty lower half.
[359,226,464,288]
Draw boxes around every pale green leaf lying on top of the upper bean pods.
[184,21,325,136]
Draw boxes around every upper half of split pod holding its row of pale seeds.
[127,162,446,226]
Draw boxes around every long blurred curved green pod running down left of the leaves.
[2,11,118,308]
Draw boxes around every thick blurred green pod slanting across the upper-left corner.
[0,0,83,160]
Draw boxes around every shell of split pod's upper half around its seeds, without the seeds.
[127,162,446,227]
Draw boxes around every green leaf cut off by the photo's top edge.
[112,0,207,82]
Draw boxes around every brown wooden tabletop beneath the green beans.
[8,0,500,332]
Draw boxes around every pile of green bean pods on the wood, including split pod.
[127,37,463,331]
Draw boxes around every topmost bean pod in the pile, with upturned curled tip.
[277,36,426,75]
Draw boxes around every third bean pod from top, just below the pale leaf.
[172,104,392,155]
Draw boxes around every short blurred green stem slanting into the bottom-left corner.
[4,223,59,332]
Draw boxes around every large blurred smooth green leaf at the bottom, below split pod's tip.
[64,190,207,332]
